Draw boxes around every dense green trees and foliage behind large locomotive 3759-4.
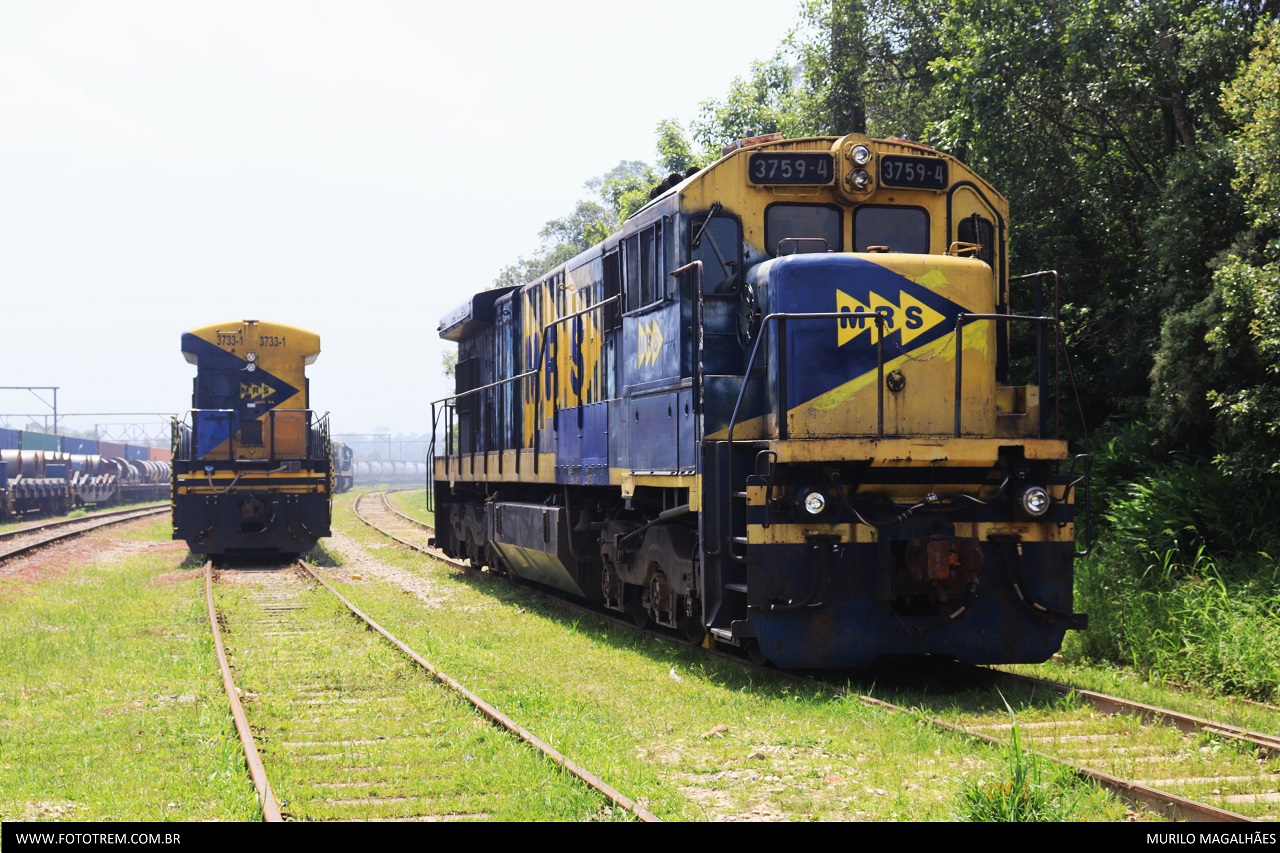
[491,0,1280,696]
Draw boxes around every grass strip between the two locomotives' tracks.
[321,496,1125,821]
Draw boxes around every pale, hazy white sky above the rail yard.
[0,0,799,433]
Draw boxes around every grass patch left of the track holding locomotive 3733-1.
[0,519,260,821]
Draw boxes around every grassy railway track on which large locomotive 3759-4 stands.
[356,492,1280,822]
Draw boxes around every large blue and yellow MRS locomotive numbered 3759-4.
[433,134,1087,669]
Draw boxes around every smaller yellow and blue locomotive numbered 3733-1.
[173,320,334,556]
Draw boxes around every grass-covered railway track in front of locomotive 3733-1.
[205,555,657,821]
